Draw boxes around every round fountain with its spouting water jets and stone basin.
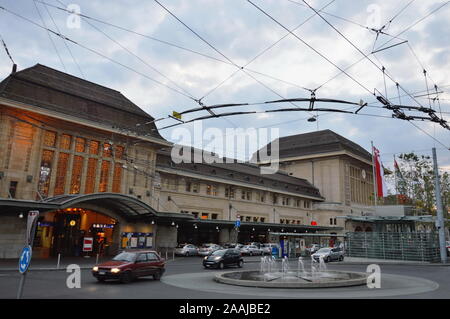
[215,256,367,288]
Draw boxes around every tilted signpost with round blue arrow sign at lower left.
[17,210,39,299]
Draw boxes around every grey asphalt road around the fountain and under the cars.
[0,257,450,299]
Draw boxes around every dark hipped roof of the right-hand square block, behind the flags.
[253,130,372,161]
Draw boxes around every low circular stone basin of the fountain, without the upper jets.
[214,270,368,288]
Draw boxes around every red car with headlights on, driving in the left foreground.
[92,250,165,283]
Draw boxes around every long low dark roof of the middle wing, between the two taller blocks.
[156,147,323,200]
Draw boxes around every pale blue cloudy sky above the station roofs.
[0,0,450,174]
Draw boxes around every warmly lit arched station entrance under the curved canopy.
[35,207,118,257]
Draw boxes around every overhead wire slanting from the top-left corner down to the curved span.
[0,6,200,100]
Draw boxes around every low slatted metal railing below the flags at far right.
[345,232,440,262]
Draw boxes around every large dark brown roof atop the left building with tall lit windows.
[0,64,163,139]
